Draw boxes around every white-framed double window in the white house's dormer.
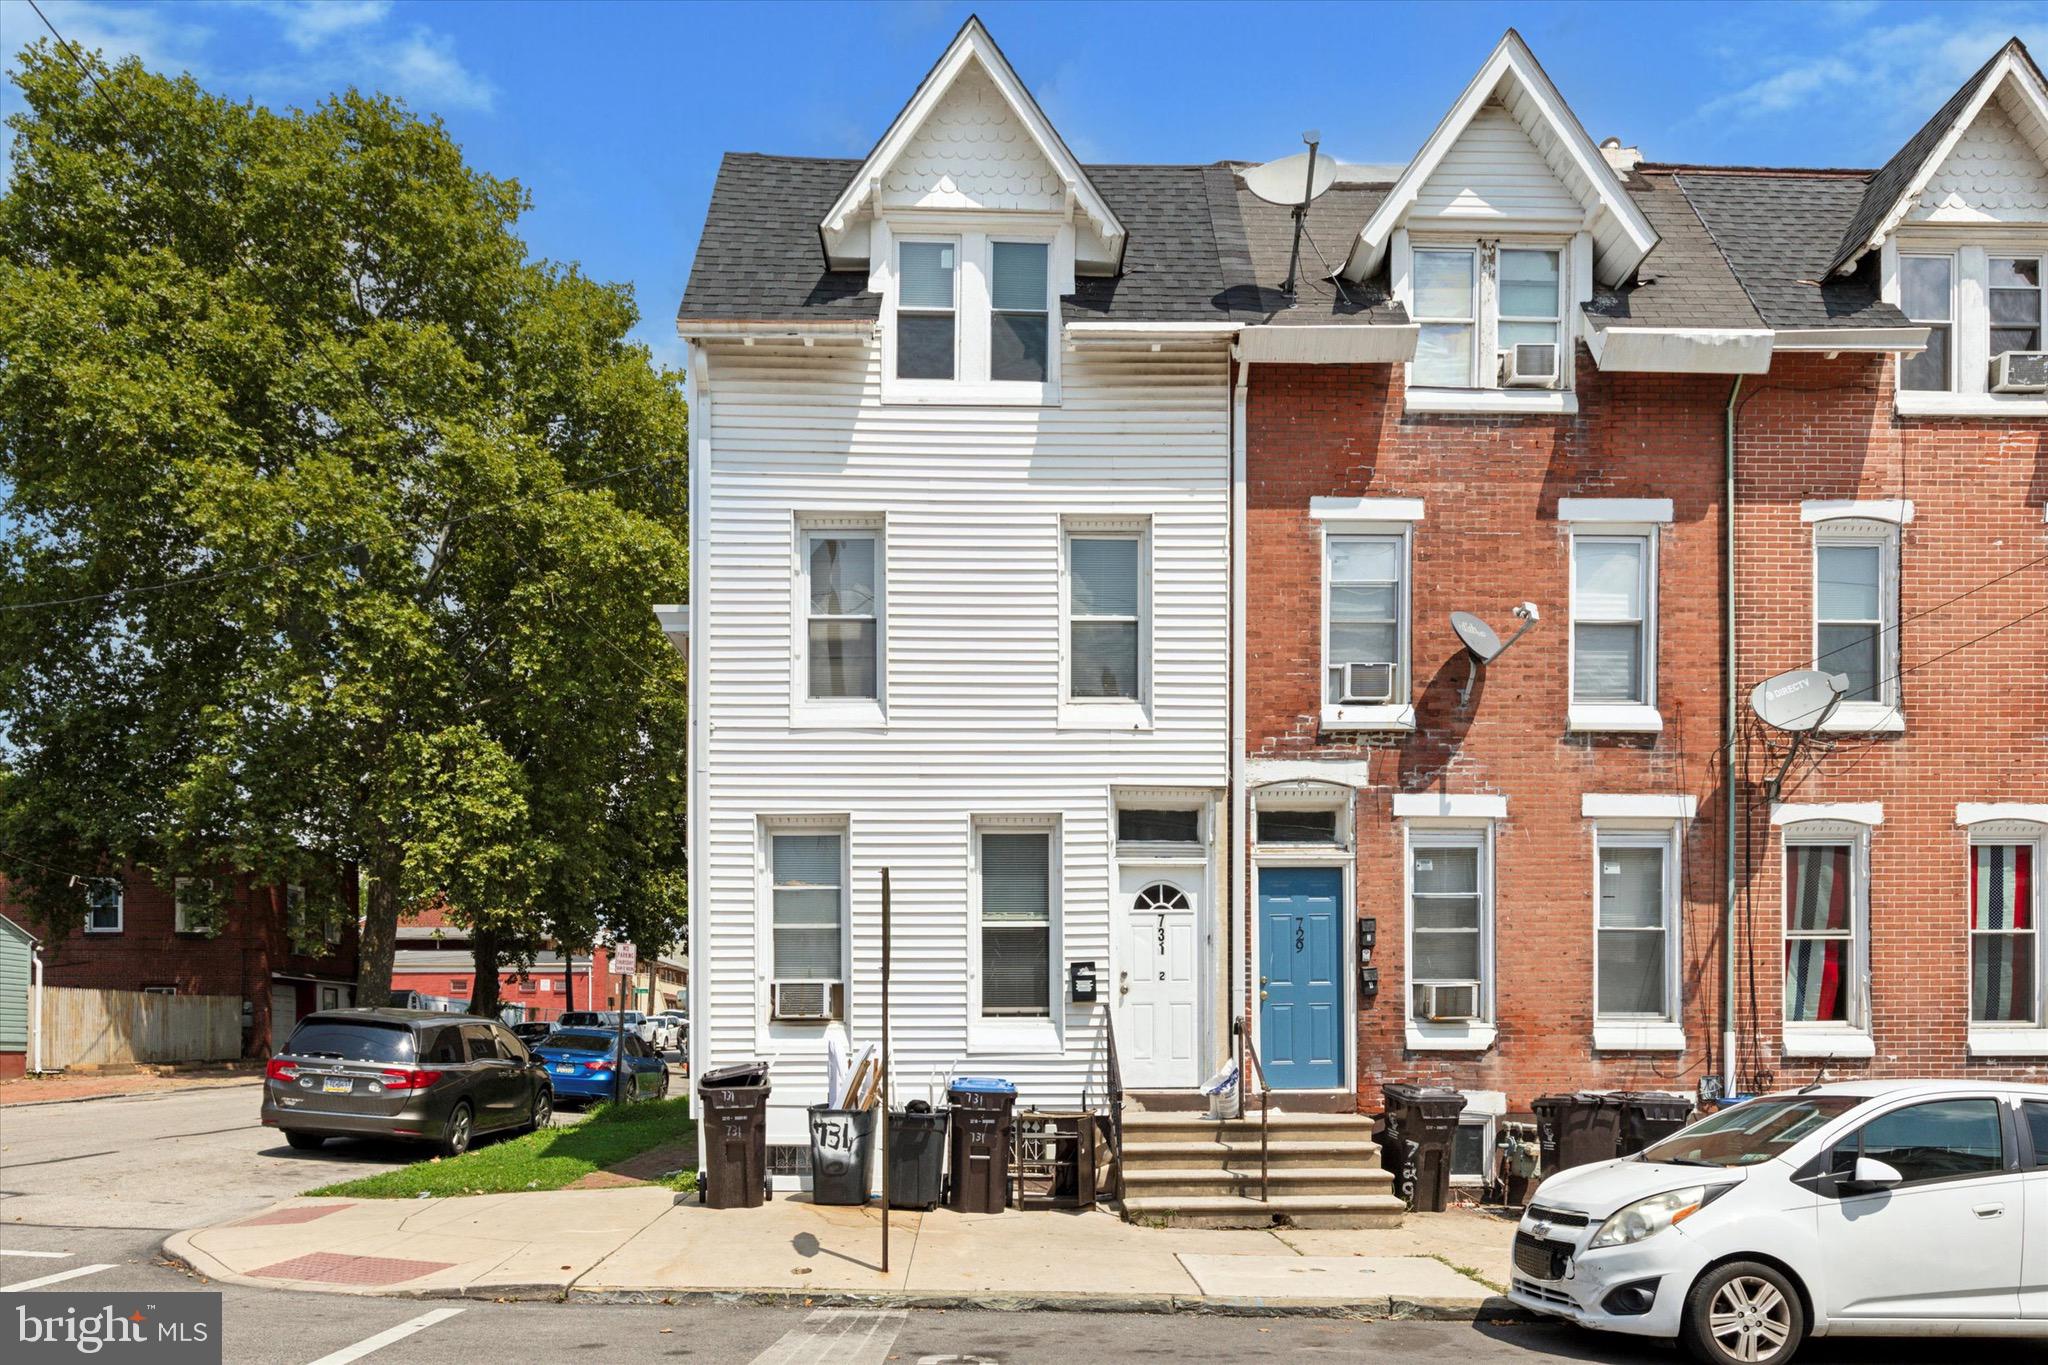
[877,227,1065,403]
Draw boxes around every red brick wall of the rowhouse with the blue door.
[1245,356,1729,1111]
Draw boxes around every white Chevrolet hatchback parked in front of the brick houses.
[1509,1081,2048,1365]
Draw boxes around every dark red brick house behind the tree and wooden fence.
[0,870,356,1058]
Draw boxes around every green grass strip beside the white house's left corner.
[305,1097,696,1199]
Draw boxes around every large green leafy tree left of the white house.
[0,43,688,1033]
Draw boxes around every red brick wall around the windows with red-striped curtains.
[1737,356,2048,1085]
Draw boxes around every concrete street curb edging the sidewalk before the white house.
[162,1228,1542,1322]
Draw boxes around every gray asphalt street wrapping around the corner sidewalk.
[0,1085,2023,1365]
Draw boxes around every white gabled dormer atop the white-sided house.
[819,18,1126,403]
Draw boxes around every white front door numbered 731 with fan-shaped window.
[1116,868,1202,1091]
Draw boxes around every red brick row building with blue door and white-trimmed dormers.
[1219,35,2048,1162]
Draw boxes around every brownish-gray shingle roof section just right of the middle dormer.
[1581,170,1763,327]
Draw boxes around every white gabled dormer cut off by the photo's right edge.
[1831,39,2048,415]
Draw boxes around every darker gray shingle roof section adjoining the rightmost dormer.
[1673,168,1911,327]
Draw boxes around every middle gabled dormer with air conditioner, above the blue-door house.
[1341,29,1657,411]
